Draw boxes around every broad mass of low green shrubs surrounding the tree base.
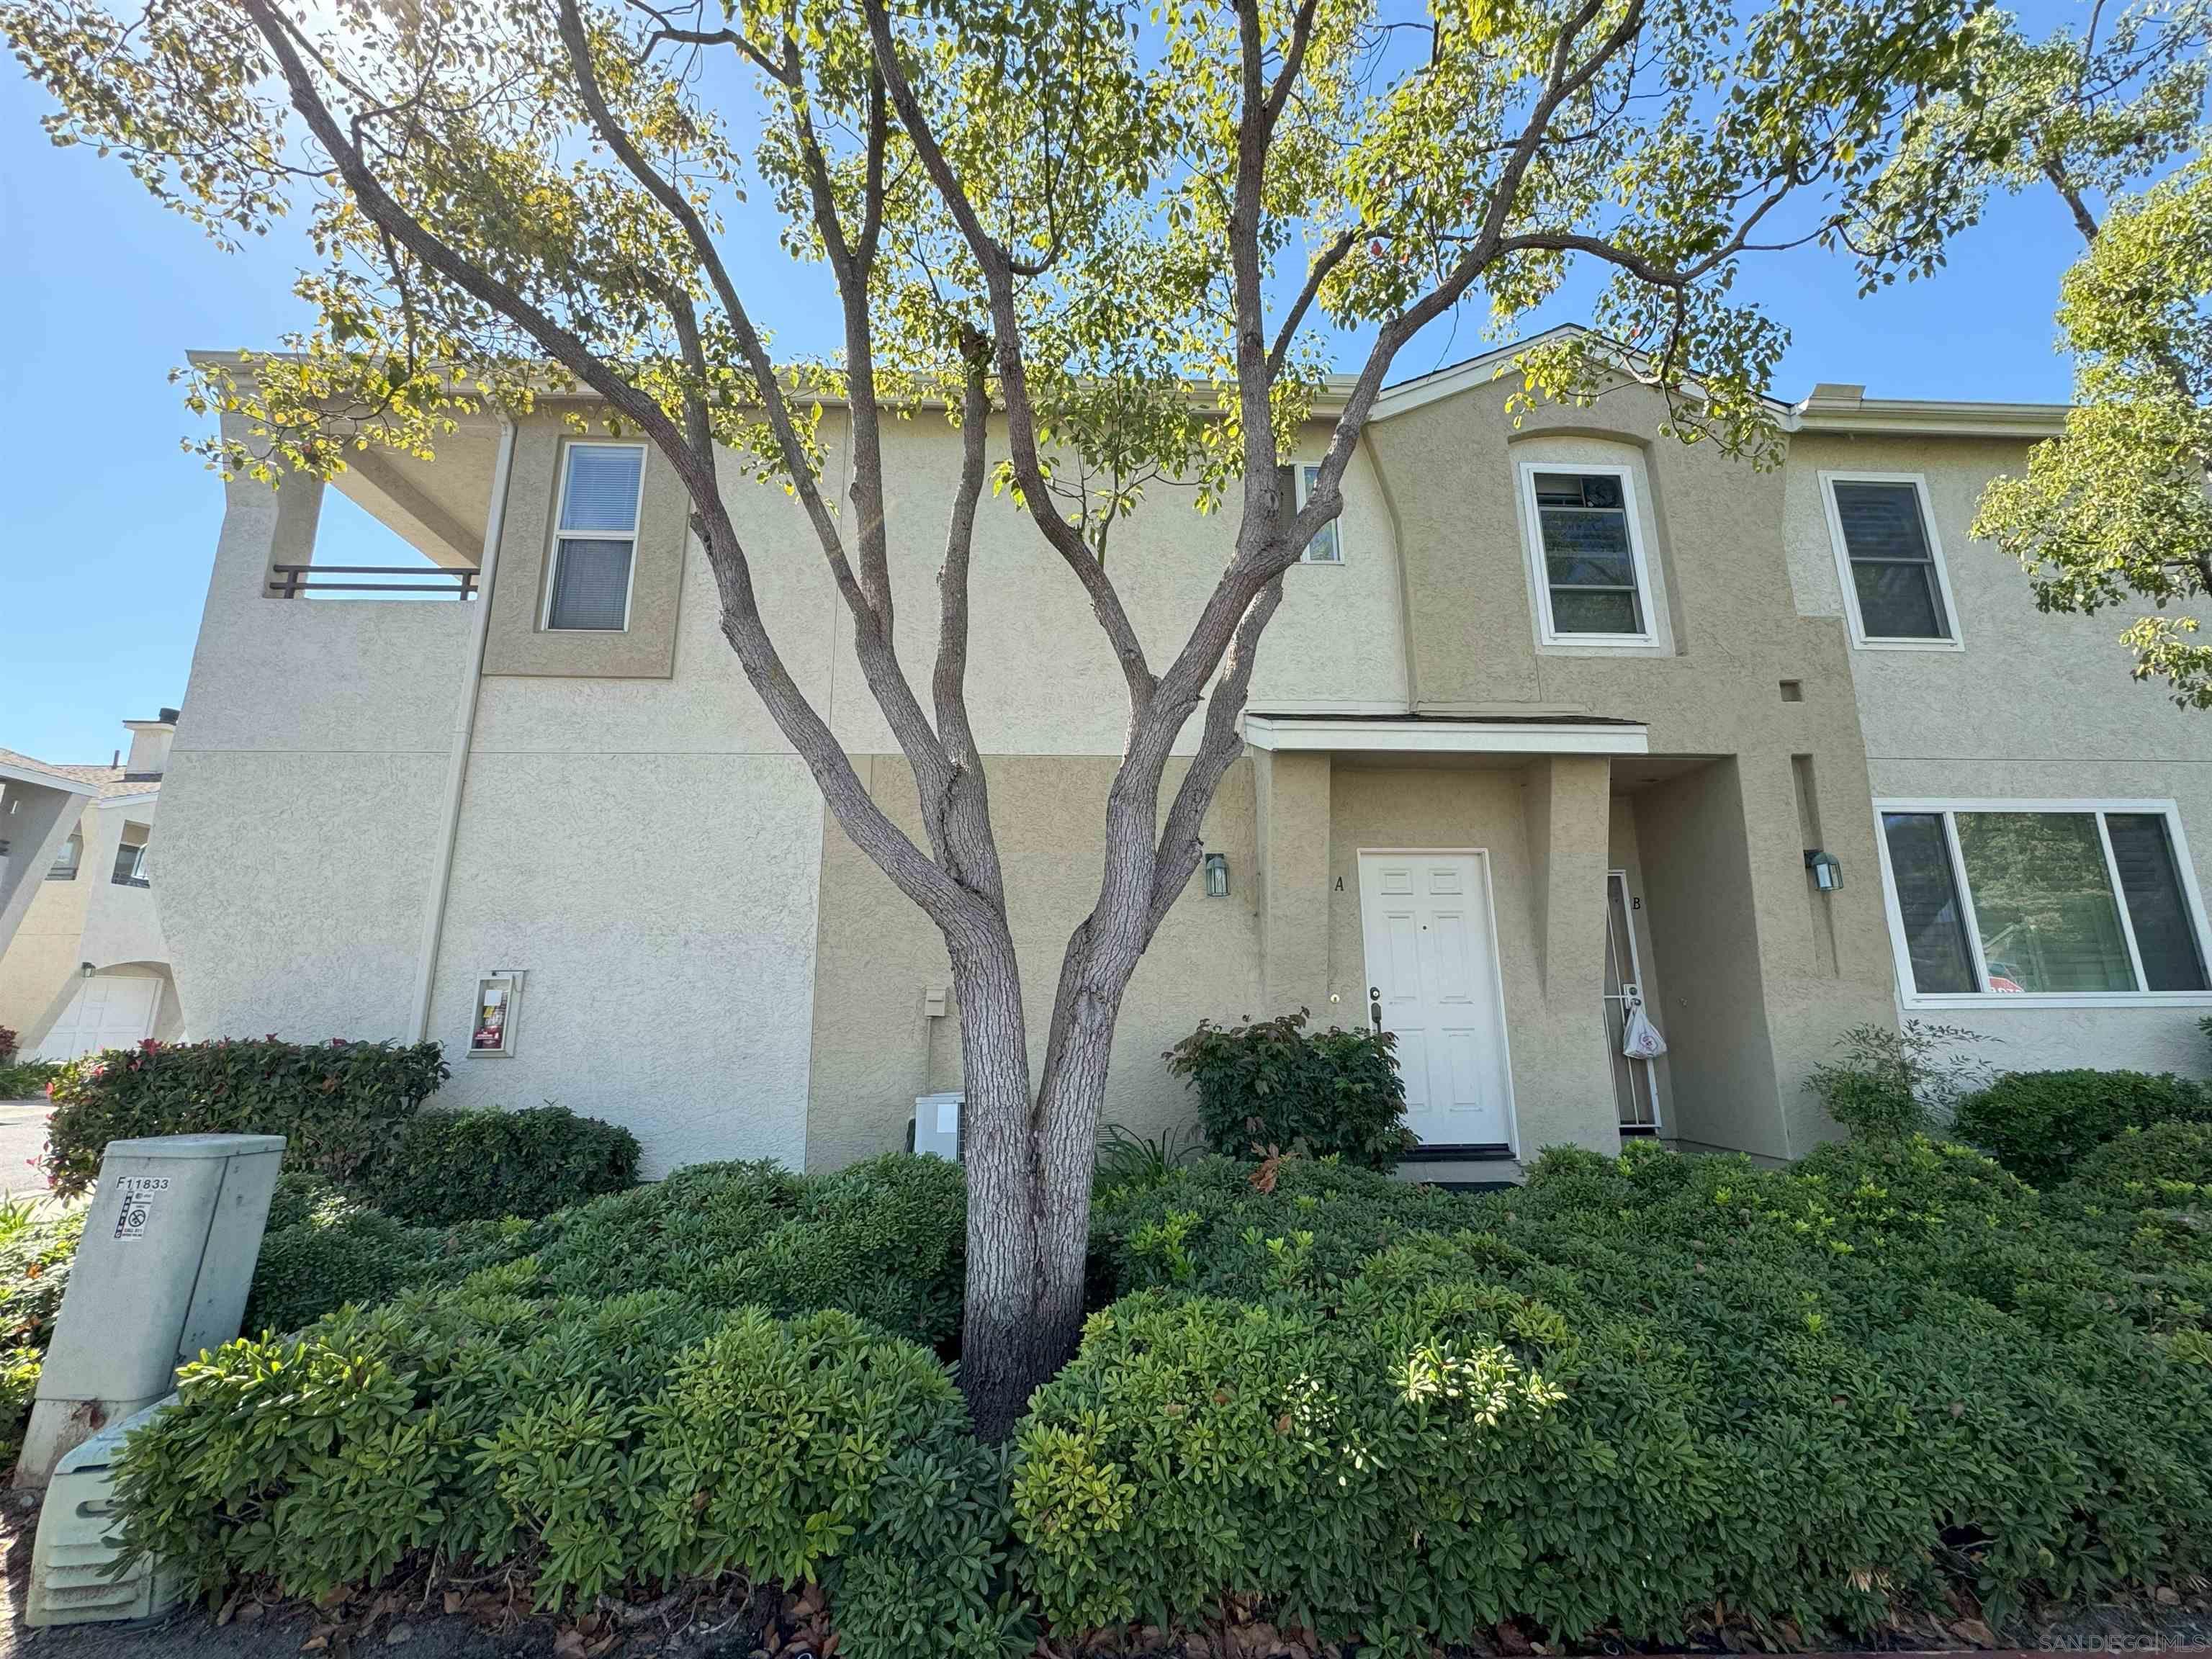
[112,1124,2212,1655]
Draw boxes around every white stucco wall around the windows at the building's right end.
[1785,433,2212,1075]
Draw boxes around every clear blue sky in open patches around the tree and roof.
[0,52,2077,761]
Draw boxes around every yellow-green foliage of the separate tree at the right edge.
[1876,0,2212,708]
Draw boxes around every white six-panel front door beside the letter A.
[1360,852,1513,1146]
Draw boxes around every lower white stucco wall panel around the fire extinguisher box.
[429,752,821,1174]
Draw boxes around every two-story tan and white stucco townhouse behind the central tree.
[161,327,2212,1174]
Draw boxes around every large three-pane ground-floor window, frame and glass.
[1880,801,2212,1007]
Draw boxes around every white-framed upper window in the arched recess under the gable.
[1522,462,1657,646]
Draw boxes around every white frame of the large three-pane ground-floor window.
[1874,796,2212,1009]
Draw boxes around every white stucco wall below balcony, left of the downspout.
[155,436,473,1040]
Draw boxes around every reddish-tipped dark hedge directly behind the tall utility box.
[47,1038,447,1197]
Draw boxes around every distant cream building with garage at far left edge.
[0,708,184,1059]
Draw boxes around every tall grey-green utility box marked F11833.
[16,1135,283,1486]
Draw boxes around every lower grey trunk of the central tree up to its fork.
[953,940,1119,1444]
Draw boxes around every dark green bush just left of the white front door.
[1164,1009,1413,1170]
